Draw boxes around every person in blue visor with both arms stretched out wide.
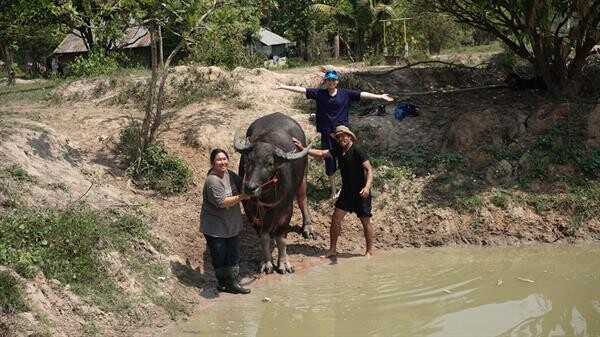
[276,68,394,199]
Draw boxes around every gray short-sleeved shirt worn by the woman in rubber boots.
[200,170,243,238]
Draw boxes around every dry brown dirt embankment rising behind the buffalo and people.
[0,61,600,336]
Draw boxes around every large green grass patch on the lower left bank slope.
[0,207,149,308]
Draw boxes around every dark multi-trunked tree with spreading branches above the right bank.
[428,0,600,95]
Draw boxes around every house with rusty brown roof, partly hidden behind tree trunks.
[53,26,152,73]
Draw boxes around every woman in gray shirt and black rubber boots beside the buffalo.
[200,149,250,294]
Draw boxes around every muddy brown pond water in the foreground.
[165,244,600,336]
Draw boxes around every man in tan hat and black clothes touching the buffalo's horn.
[292,125,373,257]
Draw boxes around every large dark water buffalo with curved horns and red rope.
[233,112,315,274]
